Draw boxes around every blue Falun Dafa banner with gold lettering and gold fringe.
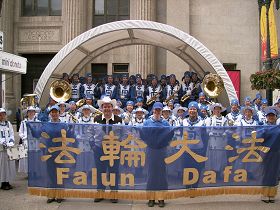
[27,122,280,199]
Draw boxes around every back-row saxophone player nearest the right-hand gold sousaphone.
[178,71,194,107]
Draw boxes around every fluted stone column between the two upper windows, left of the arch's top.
[62,0,88,44]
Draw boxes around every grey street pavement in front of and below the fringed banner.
[0,125,280,210]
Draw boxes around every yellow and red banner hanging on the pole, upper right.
[260,0,279,61]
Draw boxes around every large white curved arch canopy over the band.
[35,20,237,104]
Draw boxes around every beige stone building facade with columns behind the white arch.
[0,0,280,120]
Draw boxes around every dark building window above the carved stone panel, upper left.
[21,0,62,16]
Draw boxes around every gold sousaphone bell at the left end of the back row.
[50,79,72,102]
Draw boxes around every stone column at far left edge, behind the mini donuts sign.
[0,0,17,116]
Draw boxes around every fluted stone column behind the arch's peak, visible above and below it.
[131,0,156,78]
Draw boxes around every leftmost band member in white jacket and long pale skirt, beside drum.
[0,108,16,190]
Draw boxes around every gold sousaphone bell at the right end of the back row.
[202,73,224,98]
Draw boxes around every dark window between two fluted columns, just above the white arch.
[93,0,129,27]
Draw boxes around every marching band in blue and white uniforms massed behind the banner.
[0,71,280,207]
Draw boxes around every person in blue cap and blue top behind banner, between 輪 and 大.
[143,102,169,207]
